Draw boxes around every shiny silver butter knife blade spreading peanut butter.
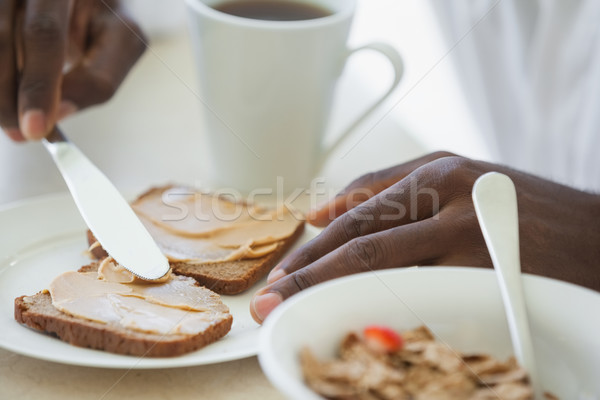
[42,127,169,280]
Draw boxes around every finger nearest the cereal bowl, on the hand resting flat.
[250,218,452,322]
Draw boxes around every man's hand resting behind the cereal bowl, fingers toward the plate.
[250,153,600,322]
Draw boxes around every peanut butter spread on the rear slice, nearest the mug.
[132,187,302,263]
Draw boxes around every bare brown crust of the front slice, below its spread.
[15,264,233,357]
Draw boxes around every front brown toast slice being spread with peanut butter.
[15,258,233,357]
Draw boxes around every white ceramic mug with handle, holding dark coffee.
[186,0,403,193]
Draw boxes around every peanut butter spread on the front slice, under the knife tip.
[49,258,229,335]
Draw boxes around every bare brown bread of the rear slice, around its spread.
[87,187,304,295]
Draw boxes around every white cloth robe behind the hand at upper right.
[431,0,600,191]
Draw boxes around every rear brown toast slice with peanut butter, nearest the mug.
[88,186,304,295]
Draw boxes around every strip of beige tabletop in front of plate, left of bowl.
[0,349,283,400]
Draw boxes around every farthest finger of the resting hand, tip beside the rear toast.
[307,151,454,227]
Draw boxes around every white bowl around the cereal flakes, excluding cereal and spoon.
[259,267,600,400]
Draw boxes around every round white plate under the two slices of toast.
[0,194,318,369]
